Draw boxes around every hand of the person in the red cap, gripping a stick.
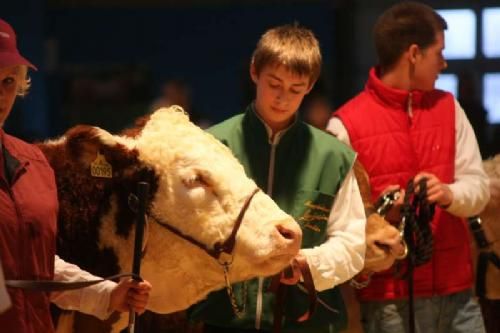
[109,279,152,314]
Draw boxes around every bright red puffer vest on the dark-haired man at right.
[335,69,472,301]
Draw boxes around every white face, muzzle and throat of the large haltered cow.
[128,109,301,312]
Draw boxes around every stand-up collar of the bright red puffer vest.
[365,67,426,111]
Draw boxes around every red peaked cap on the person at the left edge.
[0,19,37,70]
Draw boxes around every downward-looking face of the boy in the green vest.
[250,64,312,133]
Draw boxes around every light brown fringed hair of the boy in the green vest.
[252,24,322,83]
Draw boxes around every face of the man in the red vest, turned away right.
[412,31,447,91]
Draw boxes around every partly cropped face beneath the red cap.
[0,66,19,128]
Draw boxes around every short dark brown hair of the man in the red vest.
[373,1,448,69]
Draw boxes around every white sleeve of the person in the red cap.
[50,256,116,320]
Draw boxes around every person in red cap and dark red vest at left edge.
[0,19,151,333]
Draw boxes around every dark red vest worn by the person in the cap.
[0,129,58,333]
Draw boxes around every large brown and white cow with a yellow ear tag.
[40,107,301,332]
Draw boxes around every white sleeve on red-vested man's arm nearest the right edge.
[446,101,490,217]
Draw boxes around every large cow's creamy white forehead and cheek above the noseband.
[127,107,256,255]
